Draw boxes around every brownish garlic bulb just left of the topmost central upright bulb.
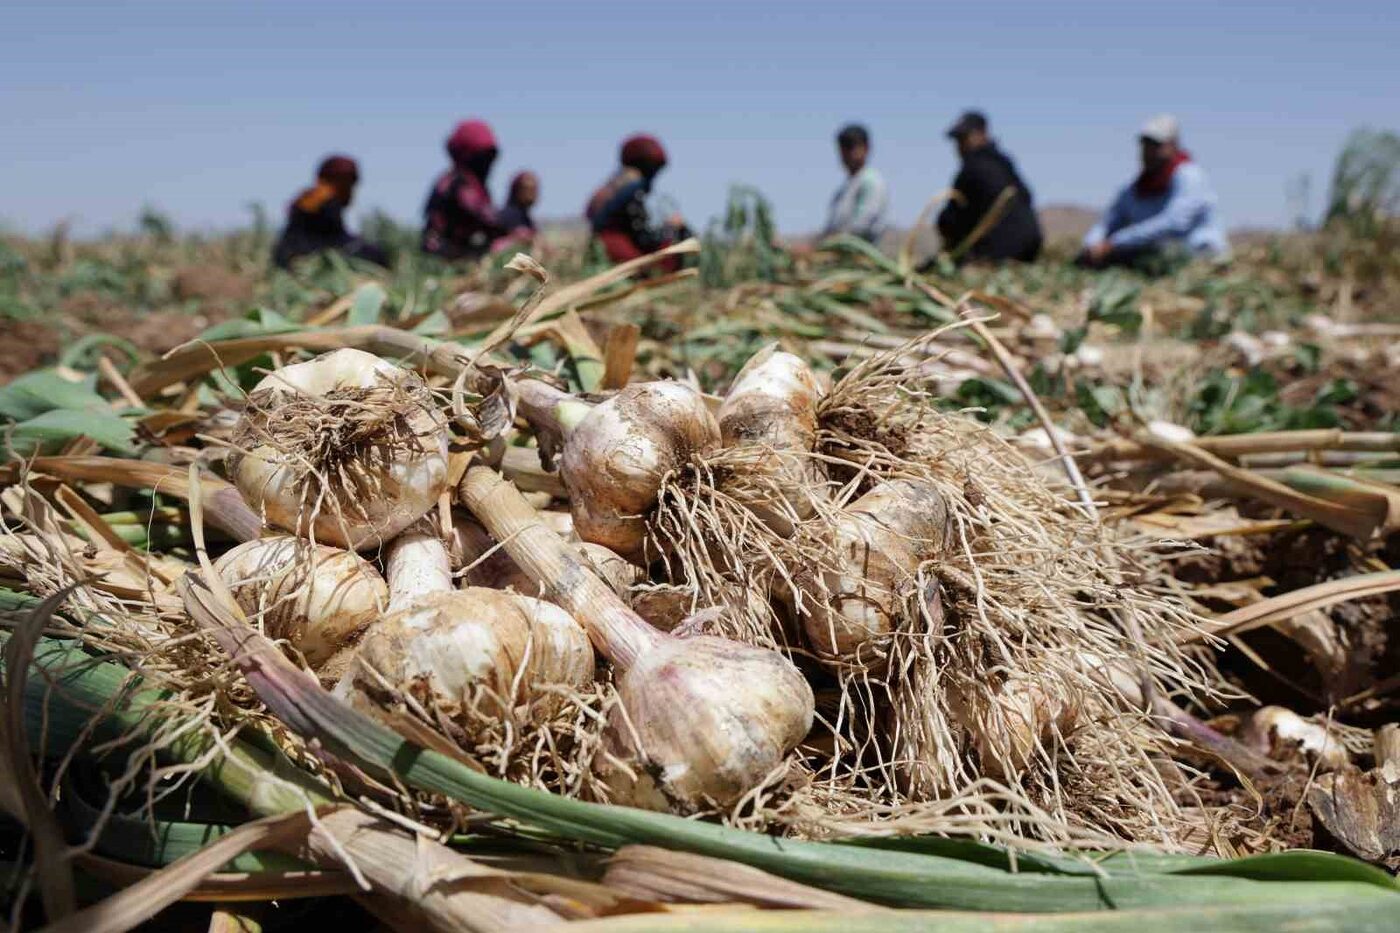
[559,382,720,558]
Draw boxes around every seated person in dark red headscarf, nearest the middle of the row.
[584,134,690,269]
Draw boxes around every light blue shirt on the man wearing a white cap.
[1084,163,1229,258]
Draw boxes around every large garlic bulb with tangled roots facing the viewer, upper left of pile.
[228,349,448,549]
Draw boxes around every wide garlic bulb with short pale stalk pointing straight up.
[350,531,594,733]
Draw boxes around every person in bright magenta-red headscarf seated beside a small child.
[421,120,510,259]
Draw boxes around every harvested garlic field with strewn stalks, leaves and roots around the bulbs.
[0,170,1400,930]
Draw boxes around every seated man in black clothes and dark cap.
[938,111,1042,262]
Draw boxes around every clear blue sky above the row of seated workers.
[0,0,1400,233]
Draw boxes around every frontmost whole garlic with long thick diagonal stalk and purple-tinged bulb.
[459,467,813,811]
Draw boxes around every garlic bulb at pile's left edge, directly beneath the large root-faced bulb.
[214,535,389,670]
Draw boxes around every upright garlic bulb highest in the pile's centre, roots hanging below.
[718,345,826,534]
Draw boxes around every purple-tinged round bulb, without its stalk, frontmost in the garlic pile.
[598,635,813,813]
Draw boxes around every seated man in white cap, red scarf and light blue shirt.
[1079,113,1229,266]
